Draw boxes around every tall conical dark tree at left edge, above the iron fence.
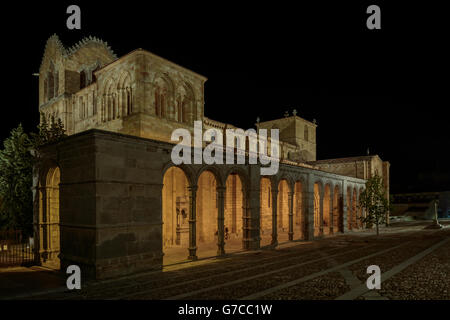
[0,124,33,234]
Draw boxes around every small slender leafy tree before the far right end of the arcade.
[359,174,391,236]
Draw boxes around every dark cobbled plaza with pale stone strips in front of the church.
[0,221,450,300]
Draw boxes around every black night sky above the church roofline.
[0,1,450,193]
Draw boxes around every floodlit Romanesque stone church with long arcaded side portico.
[33,35,389,279]
